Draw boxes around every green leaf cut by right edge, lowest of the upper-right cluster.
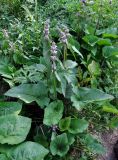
[102,46,118,58]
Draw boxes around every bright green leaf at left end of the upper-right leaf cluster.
[83,35,99,47]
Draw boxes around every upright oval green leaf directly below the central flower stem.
[43,100,64,126]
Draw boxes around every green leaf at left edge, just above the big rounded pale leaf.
[0,102,22,116]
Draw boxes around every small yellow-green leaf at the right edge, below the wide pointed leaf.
[103,105,118,114]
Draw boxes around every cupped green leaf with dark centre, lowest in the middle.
[50,133,69,157]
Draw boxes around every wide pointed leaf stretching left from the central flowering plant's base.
[5,82,47,105]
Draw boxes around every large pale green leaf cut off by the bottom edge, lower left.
[9,141,49,160]
